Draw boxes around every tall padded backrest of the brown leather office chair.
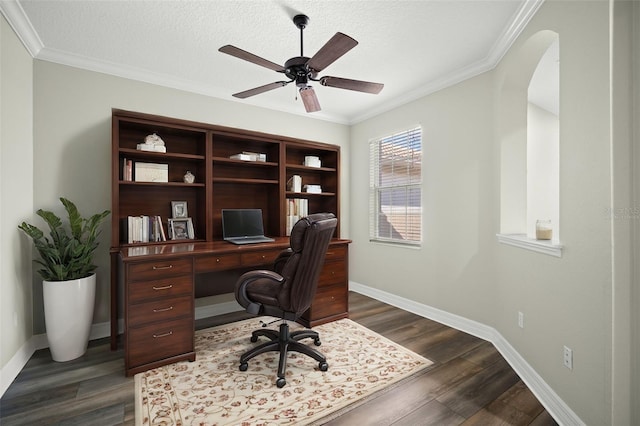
[278,213,338,316]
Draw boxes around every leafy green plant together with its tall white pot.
[18,197,110,361]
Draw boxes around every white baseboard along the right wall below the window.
[349,281,585,426]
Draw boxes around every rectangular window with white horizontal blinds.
[369,127,422,245]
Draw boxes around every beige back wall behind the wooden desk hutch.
[33,60,349,333]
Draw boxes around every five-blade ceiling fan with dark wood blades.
[218,15,384,112]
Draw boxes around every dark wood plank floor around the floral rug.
[0,292,556,426]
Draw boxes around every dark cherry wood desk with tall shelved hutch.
[111,110,350,375]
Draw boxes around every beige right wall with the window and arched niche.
[350,0,631,425]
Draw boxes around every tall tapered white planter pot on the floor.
[42,274,96,362]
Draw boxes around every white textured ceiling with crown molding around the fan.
[0,0,542,123]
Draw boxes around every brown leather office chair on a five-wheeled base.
[235,213,338,388]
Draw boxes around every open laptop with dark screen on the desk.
[222,209,275,244]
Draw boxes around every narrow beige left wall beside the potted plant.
[0,15,33,376]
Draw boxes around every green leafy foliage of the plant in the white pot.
[18,197,110,281]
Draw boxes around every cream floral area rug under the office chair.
[135,317,432,426]
